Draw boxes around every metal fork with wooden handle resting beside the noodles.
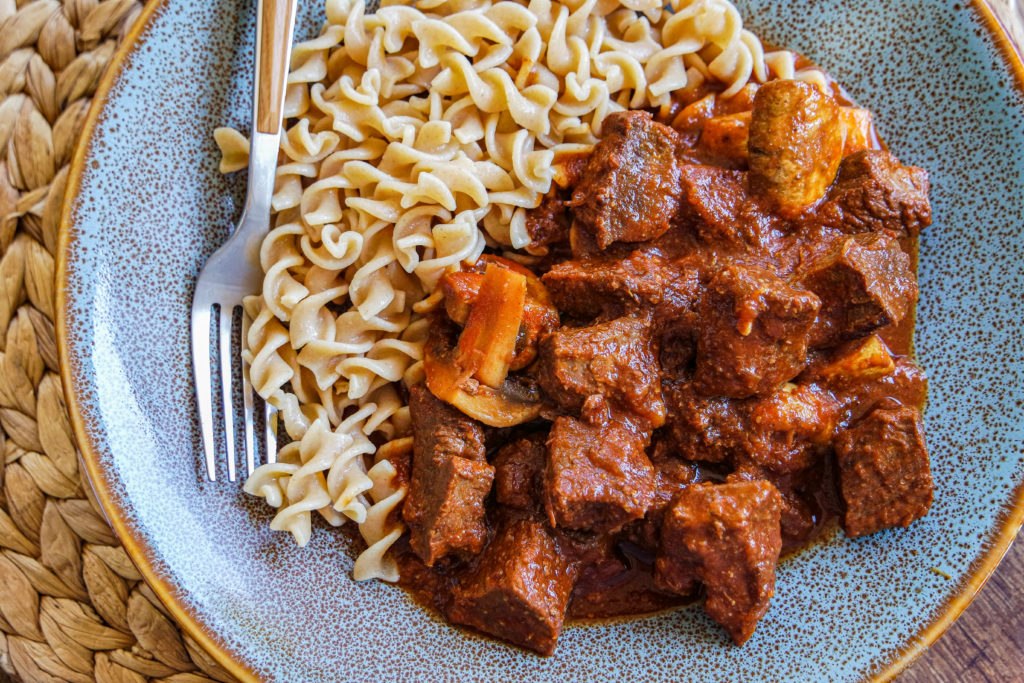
[191,0,297,481]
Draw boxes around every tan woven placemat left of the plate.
[0,0,232,683]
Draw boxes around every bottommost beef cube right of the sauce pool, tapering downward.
[654,481,782,645]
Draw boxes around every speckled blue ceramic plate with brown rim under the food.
[58,0,1024,682]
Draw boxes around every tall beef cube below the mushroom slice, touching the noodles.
[402,385,495,566]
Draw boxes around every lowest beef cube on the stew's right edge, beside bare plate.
[836,405,932,537]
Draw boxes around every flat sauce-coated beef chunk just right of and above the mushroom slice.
[541,251,700,325]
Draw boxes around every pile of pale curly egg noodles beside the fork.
[215,0,821,581]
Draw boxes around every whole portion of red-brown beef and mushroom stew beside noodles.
[387,80,932,654]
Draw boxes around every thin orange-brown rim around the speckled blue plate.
[54,0,1024,682]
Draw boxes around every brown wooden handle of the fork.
[254,0,296,135]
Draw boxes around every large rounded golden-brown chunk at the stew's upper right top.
[748,81,843,218]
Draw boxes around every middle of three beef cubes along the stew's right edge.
[799,233,918,346]
